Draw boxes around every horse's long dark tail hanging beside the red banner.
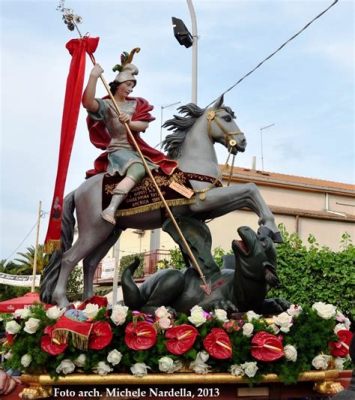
[40,191,75,304]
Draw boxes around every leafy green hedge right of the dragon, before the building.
[268,226,355,319]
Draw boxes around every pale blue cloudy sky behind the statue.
[0,0,355,259]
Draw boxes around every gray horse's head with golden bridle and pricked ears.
[205,96,247,154]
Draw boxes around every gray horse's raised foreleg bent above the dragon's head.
[190,183,280,239]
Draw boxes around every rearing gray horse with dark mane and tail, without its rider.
[41,97,281,307]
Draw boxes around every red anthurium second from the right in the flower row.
[251,331,285,361]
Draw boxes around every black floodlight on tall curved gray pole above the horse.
[172,0,198,104]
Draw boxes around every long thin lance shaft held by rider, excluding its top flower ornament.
[79,39,211,294]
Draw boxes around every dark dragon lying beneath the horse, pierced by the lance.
[121,217,289,314]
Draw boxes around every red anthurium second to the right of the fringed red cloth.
[124,321,157,350]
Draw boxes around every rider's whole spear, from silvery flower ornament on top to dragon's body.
[57,0,212,295]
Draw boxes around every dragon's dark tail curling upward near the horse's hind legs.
[121,257,144,310]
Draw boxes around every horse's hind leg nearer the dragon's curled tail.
[83,229,122,300]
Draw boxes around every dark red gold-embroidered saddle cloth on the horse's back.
[102,169,222,217]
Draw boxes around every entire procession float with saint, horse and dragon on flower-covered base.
[2,0,352,399]
